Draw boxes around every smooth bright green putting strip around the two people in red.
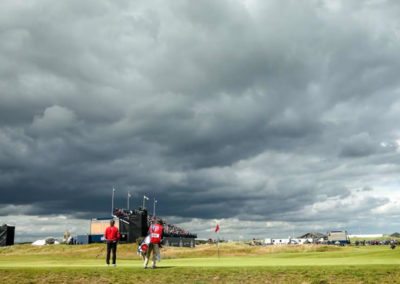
[0,247,400,268]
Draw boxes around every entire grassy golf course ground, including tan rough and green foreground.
[0,243,400,283]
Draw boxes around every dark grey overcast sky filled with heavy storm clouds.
[0,0,400,240]
